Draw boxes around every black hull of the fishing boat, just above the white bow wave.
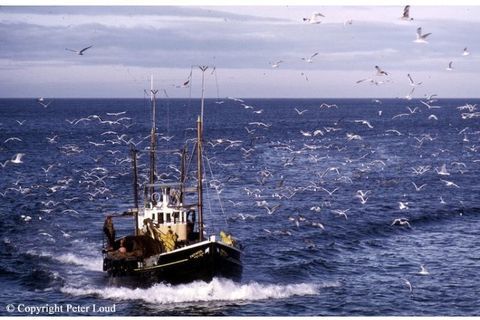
[103,241,243,286]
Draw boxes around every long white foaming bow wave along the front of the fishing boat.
[61,278,325,304]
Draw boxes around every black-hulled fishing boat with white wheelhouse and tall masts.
[102,66,243,285]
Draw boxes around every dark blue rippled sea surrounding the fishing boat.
[0,99,480,316]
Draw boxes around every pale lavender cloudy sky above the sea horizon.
[0,4,480,98]
